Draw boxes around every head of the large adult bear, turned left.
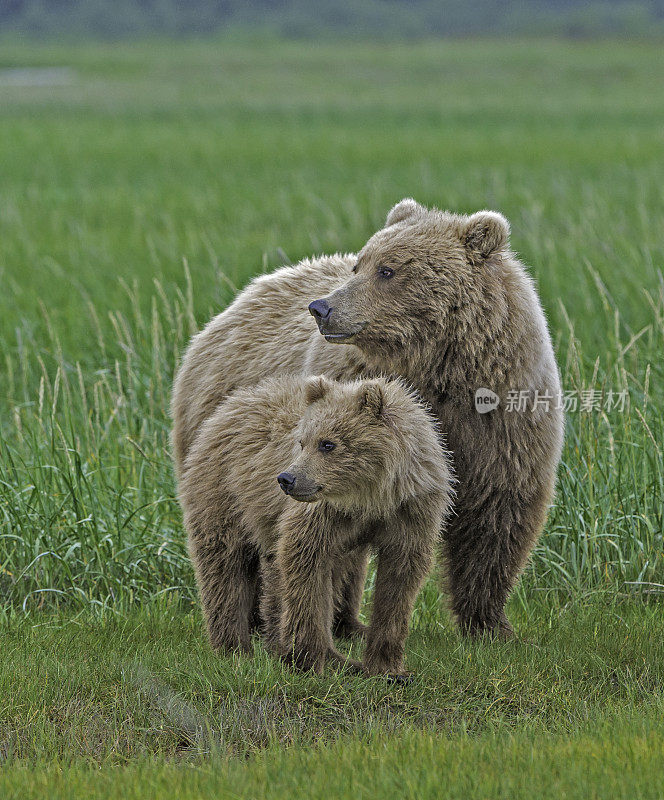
[309,198,509,357]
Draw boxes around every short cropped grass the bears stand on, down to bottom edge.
[0,602,664,798]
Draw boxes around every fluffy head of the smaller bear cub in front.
[277,377,399,509]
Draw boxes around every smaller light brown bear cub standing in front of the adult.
[180,376,452,676]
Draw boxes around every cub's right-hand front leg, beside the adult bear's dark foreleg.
[364,509,438,680]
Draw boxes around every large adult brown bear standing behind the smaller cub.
[173,198,564,634]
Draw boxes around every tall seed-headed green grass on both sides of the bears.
[0,238,664,613]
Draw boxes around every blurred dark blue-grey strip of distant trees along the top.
[0,0,664,39]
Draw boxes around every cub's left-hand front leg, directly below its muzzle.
[277,503,361,673]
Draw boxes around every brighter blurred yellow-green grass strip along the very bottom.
[5,716,664,800]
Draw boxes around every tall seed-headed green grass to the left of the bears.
[0,274,195,609]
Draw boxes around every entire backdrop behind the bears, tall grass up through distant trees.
[0,0,664,622]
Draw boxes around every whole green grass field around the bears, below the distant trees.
[0,41,664,798]
